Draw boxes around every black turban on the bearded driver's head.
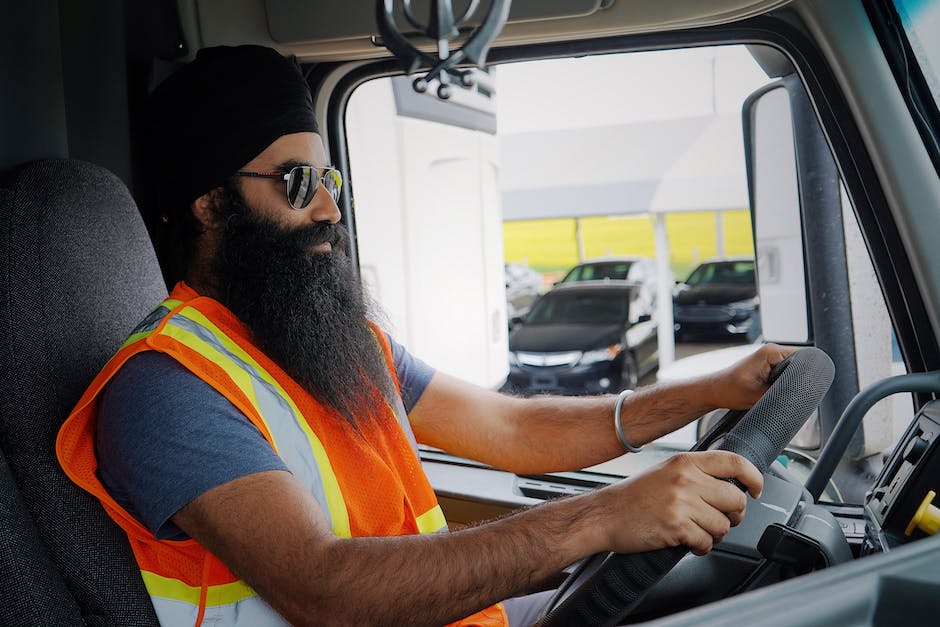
[148,46,317,220]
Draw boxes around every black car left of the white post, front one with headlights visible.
[506,281,658,395]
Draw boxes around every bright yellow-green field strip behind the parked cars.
[503,209,754,279]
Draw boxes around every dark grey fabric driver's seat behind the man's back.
[0,160,166,625]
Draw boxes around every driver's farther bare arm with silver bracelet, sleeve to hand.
[409,344,790,473]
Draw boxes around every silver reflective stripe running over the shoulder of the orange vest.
[167,314,333,526]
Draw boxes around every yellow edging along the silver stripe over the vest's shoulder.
[169,307,352,538]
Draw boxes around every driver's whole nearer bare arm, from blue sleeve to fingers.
[173,451,761,625]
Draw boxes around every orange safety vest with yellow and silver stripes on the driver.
[56,283,508,627]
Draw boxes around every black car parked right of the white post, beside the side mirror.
[673,259,760,340]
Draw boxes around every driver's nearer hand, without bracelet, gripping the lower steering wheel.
[593,451,764,555]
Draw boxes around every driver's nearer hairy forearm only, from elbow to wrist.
[239,497,602,625]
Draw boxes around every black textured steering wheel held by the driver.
[536,347,835,627]
